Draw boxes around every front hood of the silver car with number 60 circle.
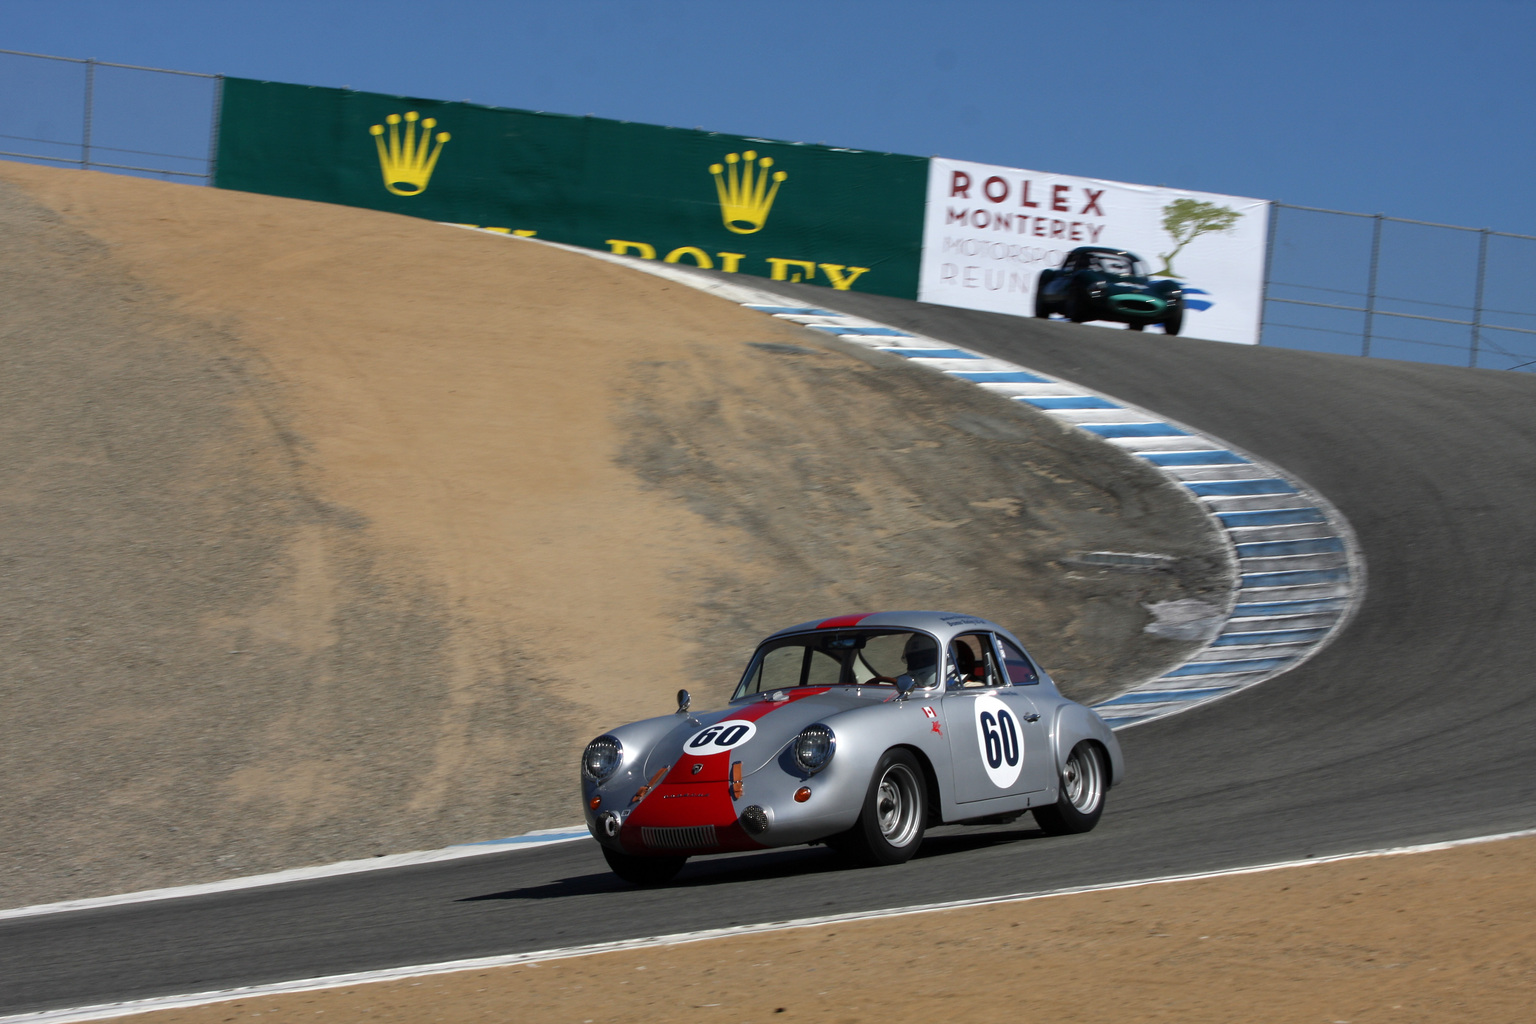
[641,686,895,781]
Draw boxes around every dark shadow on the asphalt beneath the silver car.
[456,826,1046,903]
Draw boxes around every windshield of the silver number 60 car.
[731,629,938,700]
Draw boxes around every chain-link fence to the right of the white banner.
[1263,203,1536,372]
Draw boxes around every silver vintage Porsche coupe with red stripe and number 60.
[581,611,1124,884]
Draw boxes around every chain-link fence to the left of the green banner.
[0,49,220,183]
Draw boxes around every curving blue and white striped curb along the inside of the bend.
[544,243,1366,729]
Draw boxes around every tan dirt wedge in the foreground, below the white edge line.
[123,838,1536,1024]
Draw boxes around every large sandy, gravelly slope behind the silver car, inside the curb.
[0,164,1226,906]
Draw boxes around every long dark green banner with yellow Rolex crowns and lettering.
[214,78,928,298]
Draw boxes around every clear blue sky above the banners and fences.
[0,0,1536,235]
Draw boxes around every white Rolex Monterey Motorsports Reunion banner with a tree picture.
[917,157,1269,345]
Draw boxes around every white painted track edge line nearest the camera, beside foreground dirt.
[0,827,1536,1024]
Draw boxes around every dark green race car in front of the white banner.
[1035,246,1184,335]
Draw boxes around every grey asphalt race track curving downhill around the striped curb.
[0,291,1536,1013]
